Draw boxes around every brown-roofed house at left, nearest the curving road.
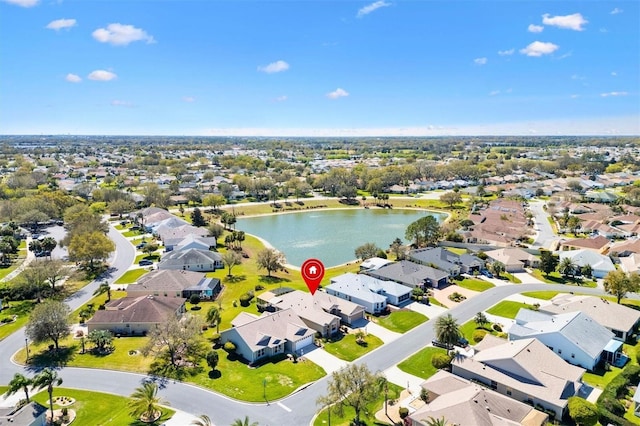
[87,296,186,335]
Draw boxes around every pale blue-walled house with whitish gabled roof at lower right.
[509,309,622,371]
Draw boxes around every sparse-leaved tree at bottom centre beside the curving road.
[319,364,379,425]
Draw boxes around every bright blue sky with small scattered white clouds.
[0,0,640,136]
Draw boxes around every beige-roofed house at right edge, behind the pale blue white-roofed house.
[540,293,640,341]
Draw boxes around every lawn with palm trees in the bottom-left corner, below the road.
[33,388,175,426]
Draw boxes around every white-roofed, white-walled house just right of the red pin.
[325,273,412,313]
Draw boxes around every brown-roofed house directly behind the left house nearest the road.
[127,269,222,299]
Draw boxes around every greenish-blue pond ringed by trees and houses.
[236,209,446,268]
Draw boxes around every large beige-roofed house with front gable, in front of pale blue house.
[451,334,585,419]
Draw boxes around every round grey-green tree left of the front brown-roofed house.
[25,300,71,350]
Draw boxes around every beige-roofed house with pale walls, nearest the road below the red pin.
[221,309,315,363]
